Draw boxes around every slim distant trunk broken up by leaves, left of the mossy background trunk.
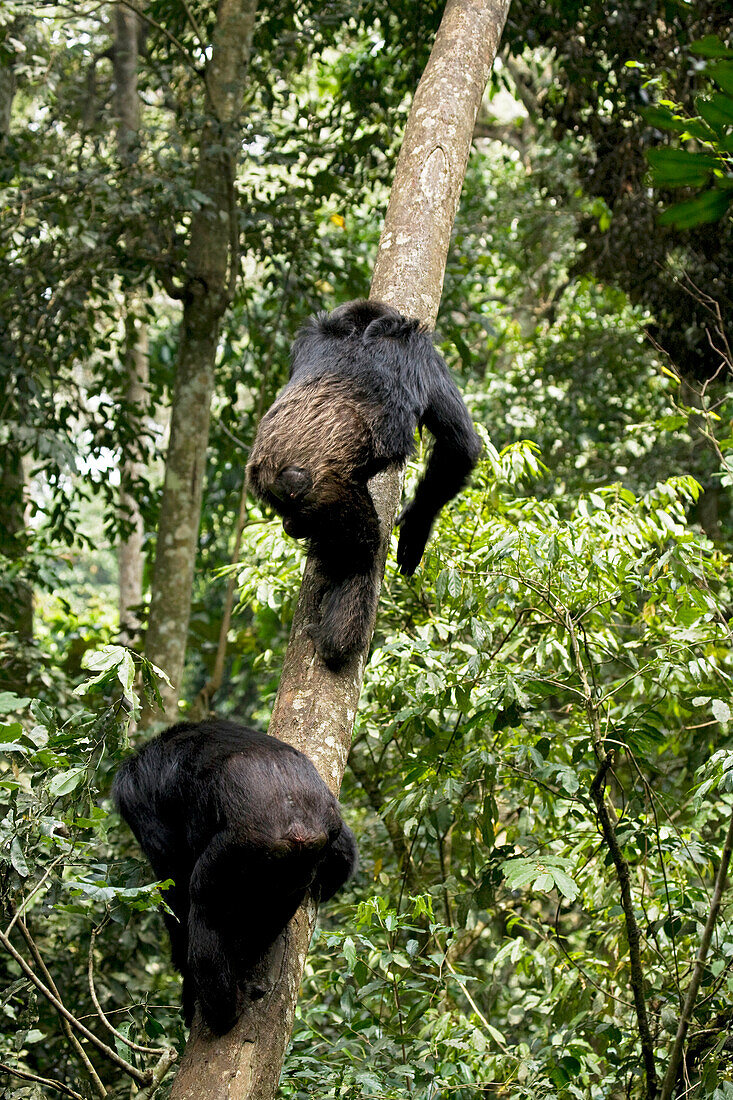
[113,0,149,646]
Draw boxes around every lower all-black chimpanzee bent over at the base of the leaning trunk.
[113,719,358,1035]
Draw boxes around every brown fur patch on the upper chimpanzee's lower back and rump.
[247,375,373,492]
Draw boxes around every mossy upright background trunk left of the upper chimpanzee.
[145,0,258,721]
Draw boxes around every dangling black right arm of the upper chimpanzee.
[397,350,481,576]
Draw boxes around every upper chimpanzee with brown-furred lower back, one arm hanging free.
[248,300,481,668]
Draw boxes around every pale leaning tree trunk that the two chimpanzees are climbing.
[171,0,510,1100]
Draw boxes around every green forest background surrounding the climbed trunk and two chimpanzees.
[0,0,733,1100]
